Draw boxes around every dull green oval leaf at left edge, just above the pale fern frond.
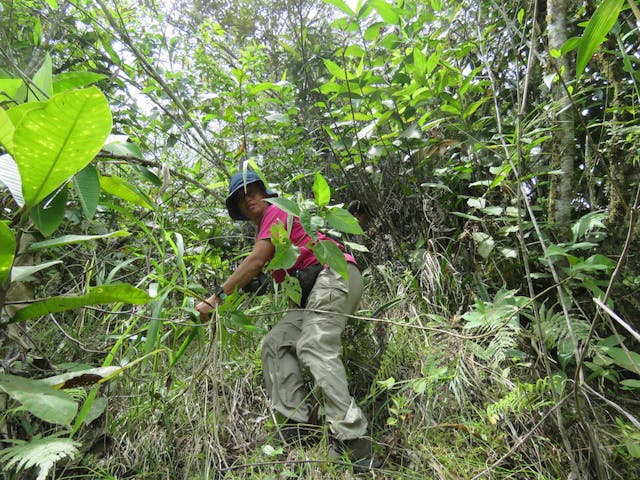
[0,374,78,425]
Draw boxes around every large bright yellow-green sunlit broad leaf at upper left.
[13,87,112,207]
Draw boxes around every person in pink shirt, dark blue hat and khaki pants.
[196,171,380,471]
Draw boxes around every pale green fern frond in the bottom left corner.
[0,435,80,480]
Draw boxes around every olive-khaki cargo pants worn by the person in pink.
[262,264,367,440]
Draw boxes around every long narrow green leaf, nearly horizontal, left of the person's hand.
[13,283,151,322]
